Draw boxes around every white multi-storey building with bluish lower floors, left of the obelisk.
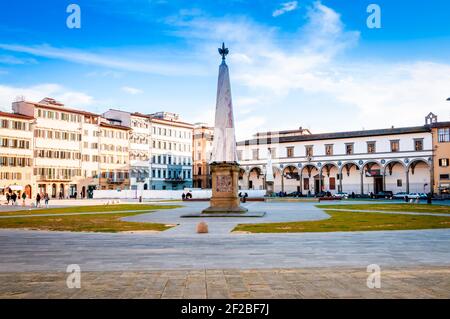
[150,112,194,189]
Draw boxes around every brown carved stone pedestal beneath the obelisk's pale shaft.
[202,163,247,214]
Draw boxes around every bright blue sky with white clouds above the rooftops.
[0,0,450,138]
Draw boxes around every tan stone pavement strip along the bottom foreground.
[0,267,450,299]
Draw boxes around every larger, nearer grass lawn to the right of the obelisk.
[233,210,450,233]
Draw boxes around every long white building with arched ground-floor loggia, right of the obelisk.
[237,126,433,195]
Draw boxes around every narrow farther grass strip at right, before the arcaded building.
[316,203,450,214]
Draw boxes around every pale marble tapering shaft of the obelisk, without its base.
[211,54,237,163]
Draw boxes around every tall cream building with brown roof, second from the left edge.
[12,98,98,198]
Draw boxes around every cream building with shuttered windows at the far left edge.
[0,112,36,198]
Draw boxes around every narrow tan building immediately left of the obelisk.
[192,123,214,188]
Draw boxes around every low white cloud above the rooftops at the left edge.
[0,83,95,111]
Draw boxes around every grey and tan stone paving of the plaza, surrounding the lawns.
[0,202,450,298]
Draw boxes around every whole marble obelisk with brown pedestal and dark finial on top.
[202,43,247,214]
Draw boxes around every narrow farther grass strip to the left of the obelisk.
[0,204,182,216]
